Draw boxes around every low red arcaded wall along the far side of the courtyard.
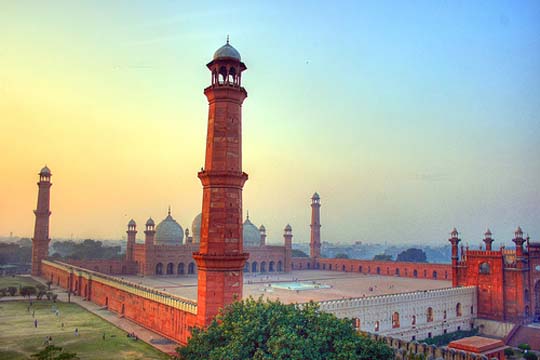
[292,258,452,281]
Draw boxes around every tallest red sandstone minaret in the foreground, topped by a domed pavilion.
[193,39,249,326]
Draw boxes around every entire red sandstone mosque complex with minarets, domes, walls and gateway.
[32,41,540,354]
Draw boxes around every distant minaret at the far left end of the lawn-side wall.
[32,166,52,276]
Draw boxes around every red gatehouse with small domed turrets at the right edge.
[449,227,540,323]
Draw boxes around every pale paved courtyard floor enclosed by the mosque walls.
[118,270,452,303]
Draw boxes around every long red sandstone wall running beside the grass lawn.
[42,264,197,344]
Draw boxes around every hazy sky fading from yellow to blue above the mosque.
[0,0,540,246]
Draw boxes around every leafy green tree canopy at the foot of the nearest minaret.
[177,298,394,360]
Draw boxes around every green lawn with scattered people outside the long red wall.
[0,301,169,360]
